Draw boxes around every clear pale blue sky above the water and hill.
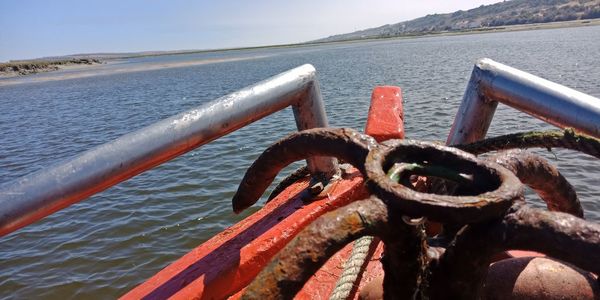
[0,0,499,61]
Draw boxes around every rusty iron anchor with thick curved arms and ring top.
[233,128,600,299]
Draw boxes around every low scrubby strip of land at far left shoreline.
[0,58,101,76]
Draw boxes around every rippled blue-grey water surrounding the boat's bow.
[0,26,600,299]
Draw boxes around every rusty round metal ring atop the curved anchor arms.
[365,140,523,224]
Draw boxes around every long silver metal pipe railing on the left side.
[0,65,337,236]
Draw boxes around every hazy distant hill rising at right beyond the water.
[313,0,600,42]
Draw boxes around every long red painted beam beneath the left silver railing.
[123,171,366,299]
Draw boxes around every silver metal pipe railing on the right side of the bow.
[446,58,600,145]
